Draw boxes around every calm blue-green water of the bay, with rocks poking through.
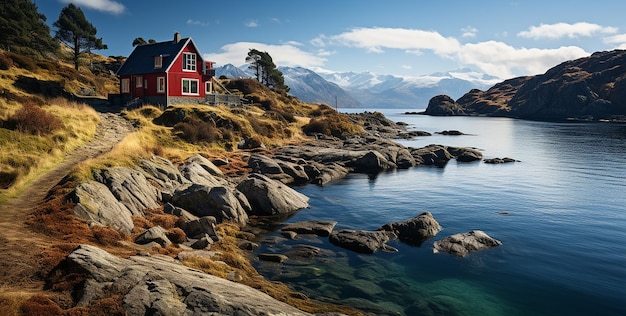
[251,110,626,315]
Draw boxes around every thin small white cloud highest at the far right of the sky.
[517,22,617,39]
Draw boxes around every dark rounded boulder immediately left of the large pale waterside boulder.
[171,184,248,225]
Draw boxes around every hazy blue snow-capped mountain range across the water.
[216,64,499,109]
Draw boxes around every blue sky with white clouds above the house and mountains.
[35,0,626,79]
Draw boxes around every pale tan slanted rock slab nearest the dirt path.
[70,181,134,234]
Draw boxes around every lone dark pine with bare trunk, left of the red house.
[53,3,107,70]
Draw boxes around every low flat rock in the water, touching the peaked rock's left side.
[329,229,396,254]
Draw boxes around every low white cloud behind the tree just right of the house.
[204,42,326,68]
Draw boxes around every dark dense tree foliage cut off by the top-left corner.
[0,0,58,54]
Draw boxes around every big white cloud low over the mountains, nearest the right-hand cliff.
[458,41,589,79]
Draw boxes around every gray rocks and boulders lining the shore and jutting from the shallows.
[55,112,500,315]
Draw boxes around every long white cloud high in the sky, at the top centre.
[313,27,460,55]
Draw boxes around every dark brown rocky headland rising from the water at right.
[424,50,626,120]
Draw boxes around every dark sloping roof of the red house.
[117,38,190,76]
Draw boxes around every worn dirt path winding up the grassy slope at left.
[0,113,134,295]
